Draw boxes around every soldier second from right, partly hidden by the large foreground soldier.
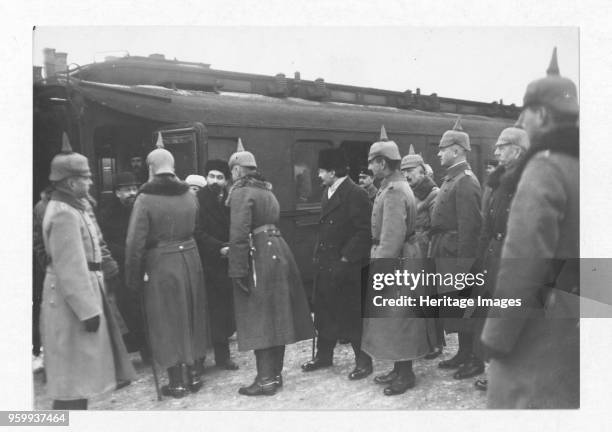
[474,127,529,390]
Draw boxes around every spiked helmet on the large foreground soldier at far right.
[523,47,579,114]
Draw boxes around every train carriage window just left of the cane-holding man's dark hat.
[293,140,332,209]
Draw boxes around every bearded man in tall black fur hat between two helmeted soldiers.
[196,159,238,370]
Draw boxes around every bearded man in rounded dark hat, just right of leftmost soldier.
[100,171,151,363]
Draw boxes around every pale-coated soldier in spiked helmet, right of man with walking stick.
[362,127,435,396]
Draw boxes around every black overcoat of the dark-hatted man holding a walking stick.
[313,177,372,342]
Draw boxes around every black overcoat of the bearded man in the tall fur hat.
[196,186,236,343]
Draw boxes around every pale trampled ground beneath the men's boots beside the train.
[34,335,486,411]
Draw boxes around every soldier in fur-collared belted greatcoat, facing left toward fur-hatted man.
[228,141,314,396]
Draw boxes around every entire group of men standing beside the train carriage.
[34,51,579,409]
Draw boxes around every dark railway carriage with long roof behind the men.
[34,55,518,285]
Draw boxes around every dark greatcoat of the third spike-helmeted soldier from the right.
[429,161,482,333]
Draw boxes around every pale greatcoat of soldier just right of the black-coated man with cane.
[361,172,436,361]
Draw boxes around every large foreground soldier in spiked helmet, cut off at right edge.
[482,48,580,409]
